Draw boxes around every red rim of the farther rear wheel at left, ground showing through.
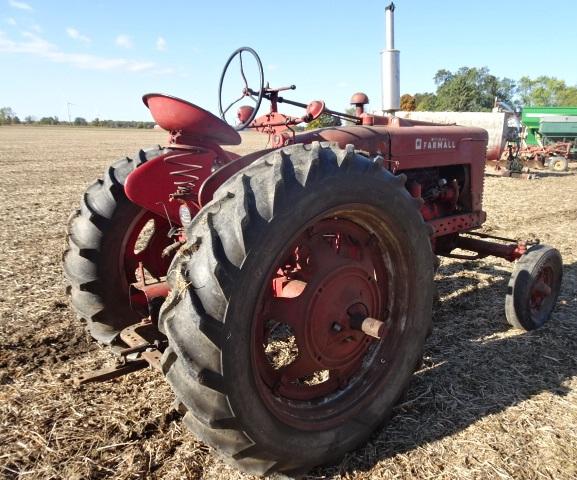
[119,210,170,287]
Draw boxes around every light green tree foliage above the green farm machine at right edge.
[518,75,577,107]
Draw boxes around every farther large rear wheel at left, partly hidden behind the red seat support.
[63,147,170,344]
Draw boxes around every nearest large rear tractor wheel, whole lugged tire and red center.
[160,143,433,475]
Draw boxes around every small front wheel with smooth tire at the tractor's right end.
[505,245,563,331]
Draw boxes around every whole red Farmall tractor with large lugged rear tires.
[64,4,562,475]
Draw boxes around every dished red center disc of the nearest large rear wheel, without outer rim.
[255,219,385,401]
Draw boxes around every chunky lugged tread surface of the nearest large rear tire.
[159,142,426,475]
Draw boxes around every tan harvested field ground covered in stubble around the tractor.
[0,127,577,479]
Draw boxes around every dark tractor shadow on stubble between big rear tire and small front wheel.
[316,261,577,475]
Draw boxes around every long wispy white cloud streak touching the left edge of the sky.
[0,31,174,74]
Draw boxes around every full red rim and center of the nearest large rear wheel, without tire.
[252,217,402,429]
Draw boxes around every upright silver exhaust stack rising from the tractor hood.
[381,2,401,115]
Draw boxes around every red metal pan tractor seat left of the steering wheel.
[142,93,241,145]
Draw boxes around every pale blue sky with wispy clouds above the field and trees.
[0,0,577,120]
